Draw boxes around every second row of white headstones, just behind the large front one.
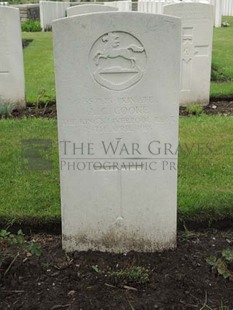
[0,3,213,110]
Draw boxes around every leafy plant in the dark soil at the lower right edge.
[206,249,233,280]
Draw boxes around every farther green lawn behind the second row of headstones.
[23,17,233,103]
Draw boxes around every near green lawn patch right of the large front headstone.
[178,115,233,223]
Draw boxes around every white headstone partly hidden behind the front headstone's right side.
[164,3,214,106]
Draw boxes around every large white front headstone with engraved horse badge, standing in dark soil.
[53,12,181,252]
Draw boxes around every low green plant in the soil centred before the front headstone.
[108,266,149,284]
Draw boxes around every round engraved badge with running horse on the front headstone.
[89,31,147,90]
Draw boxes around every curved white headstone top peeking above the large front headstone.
[67,4,118,17]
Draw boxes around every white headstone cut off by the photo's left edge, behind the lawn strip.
[0,6,25,113]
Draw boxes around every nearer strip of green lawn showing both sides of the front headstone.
[0,116,233,223]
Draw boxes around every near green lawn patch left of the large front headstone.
[0,119,60,222]
